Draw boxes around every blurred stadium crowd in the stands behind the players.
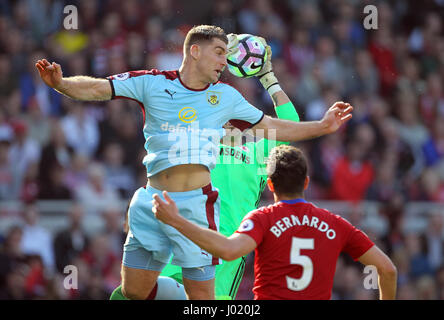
[0,0,444,299]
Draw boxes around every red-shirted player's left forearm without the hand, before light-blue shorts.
[170,216,242,261]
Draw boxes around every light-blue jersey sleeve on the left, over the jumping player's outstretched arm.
[107,70,150,103]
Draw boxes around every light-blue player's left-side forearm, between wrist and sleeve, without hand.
[54,76,112,101]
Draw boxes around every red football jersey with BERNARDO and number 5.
[236,199,374,300]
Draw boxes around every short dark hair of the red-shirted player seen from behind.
[267,145,308,195]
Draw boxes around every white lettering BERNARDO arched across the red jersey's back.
[270,214,336,240]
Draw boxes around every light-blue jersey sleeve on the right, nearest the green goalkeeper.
[230,88,265,131]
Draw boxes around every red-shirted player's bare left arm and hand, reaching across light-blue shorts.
[152,191,256,261]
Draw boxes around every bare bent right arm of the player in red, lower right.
[358,246,397,300]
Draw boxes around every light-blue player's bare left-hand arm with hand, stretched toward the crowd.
[35,59,112,101]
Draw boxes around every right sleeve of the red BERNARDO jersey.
[339,217,375,261]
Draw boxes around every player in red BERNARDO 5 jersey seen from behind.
[153,145,397,300]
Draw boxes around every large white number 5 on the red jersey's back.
[285,237,314,291]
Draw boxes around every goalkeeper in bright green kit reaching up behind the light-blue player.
[110,34,299,300]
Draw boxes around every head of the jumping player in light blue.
[183,25,228,83]
